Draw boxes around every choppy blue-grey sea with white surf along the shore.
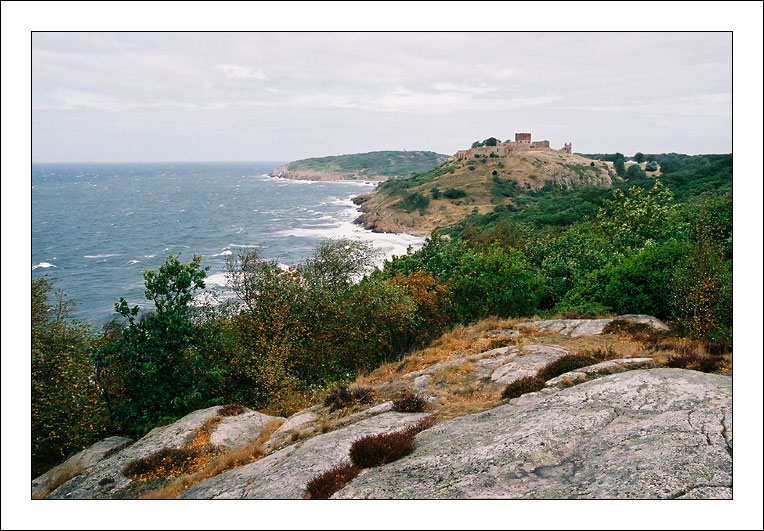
[31,162,424,327]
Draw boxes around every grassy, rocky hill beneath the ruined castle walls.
[355,148,621,234]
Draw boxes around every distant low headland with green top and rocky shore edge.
[270,151,448,181]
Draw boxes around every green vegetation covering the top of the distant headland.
[287,151,447,177]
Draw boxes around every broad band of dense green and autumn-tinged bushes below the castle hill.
[32,155,732,477]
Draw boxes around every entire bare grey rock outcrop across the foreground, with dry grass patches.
[33,316,732,499]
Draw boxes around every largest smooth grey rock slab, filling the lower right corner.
[334,369,732,499]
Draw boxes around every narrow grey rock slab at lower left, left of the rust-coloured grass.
[48,406,220,500]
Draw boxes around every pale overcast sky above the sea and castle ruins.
[32,33,732,162]
